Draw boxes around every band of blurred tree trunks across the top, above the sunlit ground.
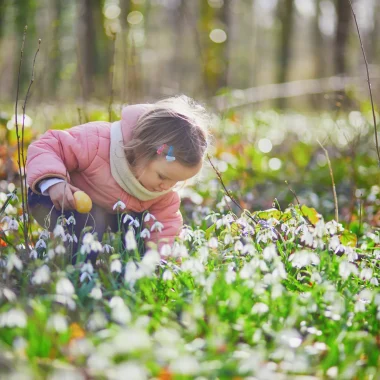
[0,0,380,109]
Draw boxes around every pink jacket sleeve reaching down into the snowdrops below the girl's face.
[144,191,183,251]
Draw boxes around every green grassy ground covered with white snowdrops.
[0,108,380,380]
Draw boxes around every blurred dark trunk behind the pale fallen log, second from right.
[277,0,294,108]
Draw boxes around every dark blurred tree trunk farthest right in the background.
[335,0,352,74]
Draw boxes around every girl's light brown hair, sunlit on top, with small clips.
[124,95,210,167]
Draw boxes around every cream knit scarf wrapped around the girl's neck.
[110,121,172,201]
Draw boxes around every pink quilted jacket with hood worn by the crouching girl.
[26,105,182,244]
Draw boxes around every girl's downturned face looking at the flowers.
[132,157,202,192]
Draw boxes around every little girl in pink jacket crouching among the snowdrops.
[26,96,209,260]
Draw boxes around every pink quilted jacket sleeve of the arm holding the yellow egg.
[26,123,99,194]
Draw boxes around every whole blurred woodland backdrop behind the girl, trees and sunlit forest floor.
[0,0,380,226]
